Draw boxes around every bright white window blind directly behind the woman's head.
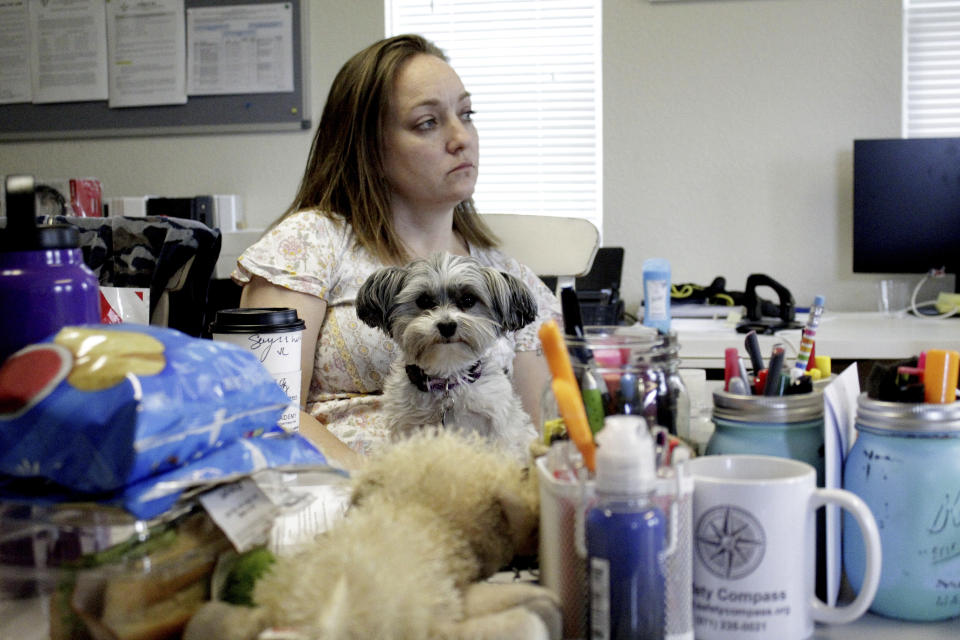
[385,0,602,228]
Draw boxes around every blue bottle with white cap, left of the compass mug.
[586,415,666,640]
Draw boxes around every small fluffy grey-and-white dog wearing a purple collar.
[356,254,537,459]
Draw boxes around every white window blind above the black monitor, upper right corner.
[903,0,960,138]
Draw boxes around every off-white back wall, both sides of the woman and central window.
[0,0,916,309]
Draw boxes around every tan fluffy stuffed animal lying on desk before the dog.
[185,431,561,640]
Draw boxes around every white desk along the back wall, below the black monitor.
[671,310,960,370]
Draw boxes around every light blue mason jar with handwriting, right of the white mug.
[843,394,960,621]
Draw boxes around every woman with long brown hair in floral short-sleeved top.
[233,35,560,468]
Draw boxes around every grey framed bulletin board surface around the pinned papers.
[0,0,311,141]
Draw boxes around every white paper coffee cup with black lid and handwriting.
[210,308,305,432]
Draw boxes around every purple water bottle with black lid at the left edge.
[0,176,100,363]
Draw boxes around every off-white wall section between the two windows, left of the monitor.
[603,0,901,310]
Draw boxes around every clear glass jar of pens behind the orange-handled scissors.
[541,326,690,444]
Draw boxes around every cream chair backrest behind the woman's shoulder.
[481,213,600,286]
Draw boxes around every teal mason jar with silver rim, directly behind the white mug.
[706,390,824,487]
